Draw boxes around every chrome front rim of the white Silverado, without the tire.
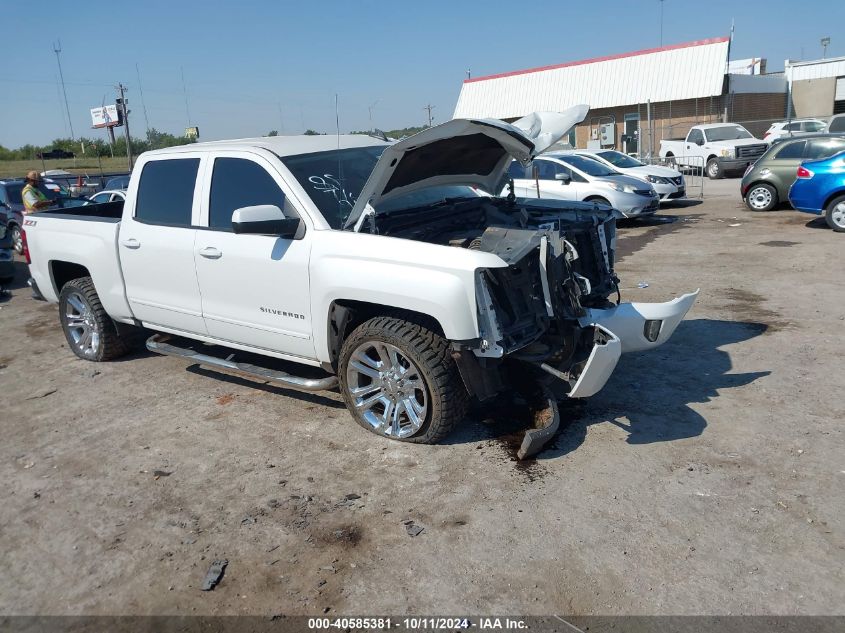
[346,341,428,438]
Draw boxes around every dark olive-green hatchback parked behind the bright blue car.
[740,134,845,211]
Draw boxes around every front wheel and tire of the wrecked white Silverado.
[338,317,468,444]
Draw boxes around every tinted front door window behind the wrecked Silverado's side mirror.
[208,158,285,231]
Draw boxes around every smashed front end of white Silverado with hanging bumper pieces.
[446,200,697,458]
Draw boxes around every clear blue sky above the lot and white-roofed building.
[0,0,845,148]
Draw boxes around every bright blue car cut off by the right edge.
[789,152,845,233]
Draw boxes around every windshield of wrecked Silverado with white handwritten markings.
[281,145,387,229]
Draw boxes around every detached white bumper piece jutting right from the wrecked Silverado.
[578,290,699,353]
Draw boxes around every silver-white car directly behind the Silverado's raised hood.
[508,152,660,217]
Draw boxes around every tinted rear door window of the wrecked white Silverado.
[135,158,200,226]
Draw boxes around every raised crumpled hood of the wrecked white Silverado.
[344,105,589,228]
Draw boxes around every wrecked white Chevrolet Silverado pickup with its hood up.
[24,106,697,454]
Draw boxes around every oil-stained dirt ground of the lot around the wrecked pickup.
[0,179,845,615]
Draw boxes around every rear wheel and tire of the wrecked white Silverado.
[59,277,132,362]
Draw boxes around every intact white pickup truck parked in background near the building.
[660,123,769,179]
